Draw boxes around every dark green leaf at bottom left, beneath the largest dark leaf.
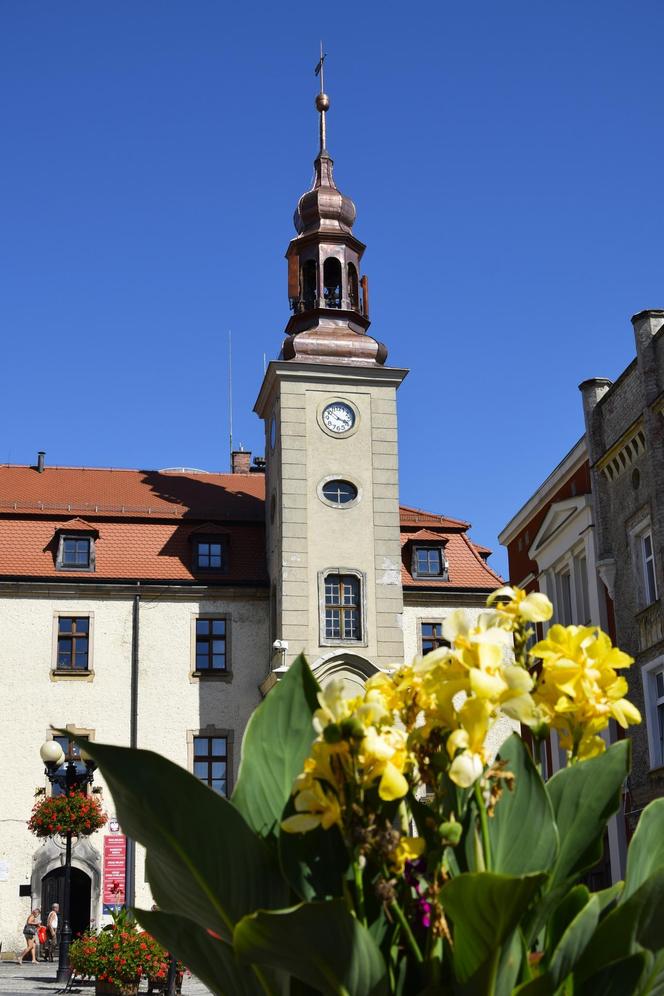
[135,910,270,996]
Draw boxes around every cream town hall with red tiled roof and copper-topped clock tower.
[0,87,501,950]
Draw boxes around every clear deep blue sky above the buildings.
[0,0,664,569]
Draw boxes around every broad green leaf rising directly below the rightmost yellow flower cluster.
[546,740,630,888]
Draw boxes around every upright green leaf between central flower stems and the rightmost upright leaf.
[489,733,558,875]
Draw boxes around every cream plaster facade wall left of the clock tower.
[0,583,268,951]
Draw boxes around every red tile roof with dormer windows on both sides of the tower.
[0,465,502,591]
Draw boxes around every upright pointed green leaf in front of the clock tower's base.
[232,654,320,837]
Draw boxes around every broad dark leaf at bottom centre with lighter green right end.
[234,899,387,996]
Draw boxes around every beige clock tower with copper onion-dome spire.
[255,78,407,684]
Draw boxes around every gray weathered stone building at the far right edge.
[580,311,664,828]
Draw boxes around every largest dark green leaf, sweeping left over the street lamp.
[70,740,288,939]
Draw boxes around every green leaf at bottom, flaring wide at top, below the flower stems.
[440,872,546,994]
